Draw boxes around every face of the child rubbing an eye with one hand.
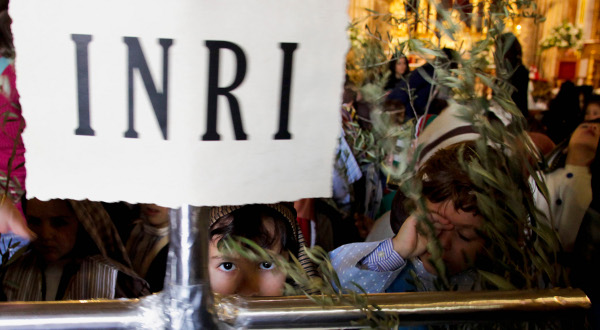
[421,201,484,275]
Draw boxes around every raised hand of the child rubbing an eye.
[392,213,454,259]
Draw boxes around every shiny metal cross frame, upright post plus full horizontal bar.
[0,206,591,329]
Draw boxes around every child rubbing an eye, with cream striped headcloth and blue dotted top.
[330,104,531,293]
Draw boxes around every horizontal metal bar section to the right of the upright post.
[216,289,591,329]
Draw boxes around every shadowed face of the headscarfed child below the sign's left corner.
[26,199,79,263]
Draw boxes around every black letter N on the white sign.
[123,37,173,140]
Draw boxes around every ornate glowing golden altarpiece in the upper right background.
[348,0,600,89]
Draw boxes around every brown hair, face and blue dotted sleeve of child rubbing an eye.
[331,143,485,293]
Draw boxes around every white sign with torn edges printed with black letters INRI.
[10,0,348,207]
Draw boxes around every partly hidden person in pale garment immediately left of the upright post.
[126,204,170,292]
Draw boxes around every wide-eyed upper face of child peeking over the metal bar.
[208,217,287,296]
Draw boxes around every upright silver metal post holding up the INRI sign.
[163,205,216,329]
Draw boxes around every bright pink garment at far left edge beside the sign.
[0,64,26,213]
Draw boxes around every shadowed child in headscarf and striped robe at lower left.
[1,199,150,301]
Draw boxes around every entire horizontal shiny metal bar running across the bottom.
[0,289,591,329]
